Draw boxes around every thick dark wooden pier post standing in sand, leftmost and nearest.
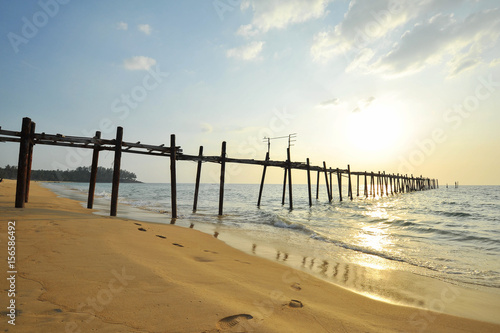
[15,118,31,208]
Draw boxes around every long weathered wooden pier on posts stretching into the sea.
[0,118,439,219]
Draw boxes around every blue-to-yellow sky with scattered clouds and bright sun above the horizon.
[0,0,500,185]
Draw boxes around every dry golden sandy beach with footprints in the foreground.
[0,180,500,332]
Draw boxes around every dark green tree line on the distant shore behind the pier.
[0,165,140,183]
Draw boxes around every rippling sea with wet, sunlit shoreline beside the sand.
[43,183,500,323]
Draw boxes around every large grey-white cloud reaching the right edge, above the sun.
[372,9,500,74]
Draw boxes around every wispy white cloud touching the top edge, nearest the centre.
[238,0,331,33]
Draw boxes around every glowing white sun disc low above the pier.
[345,103,405,153]
